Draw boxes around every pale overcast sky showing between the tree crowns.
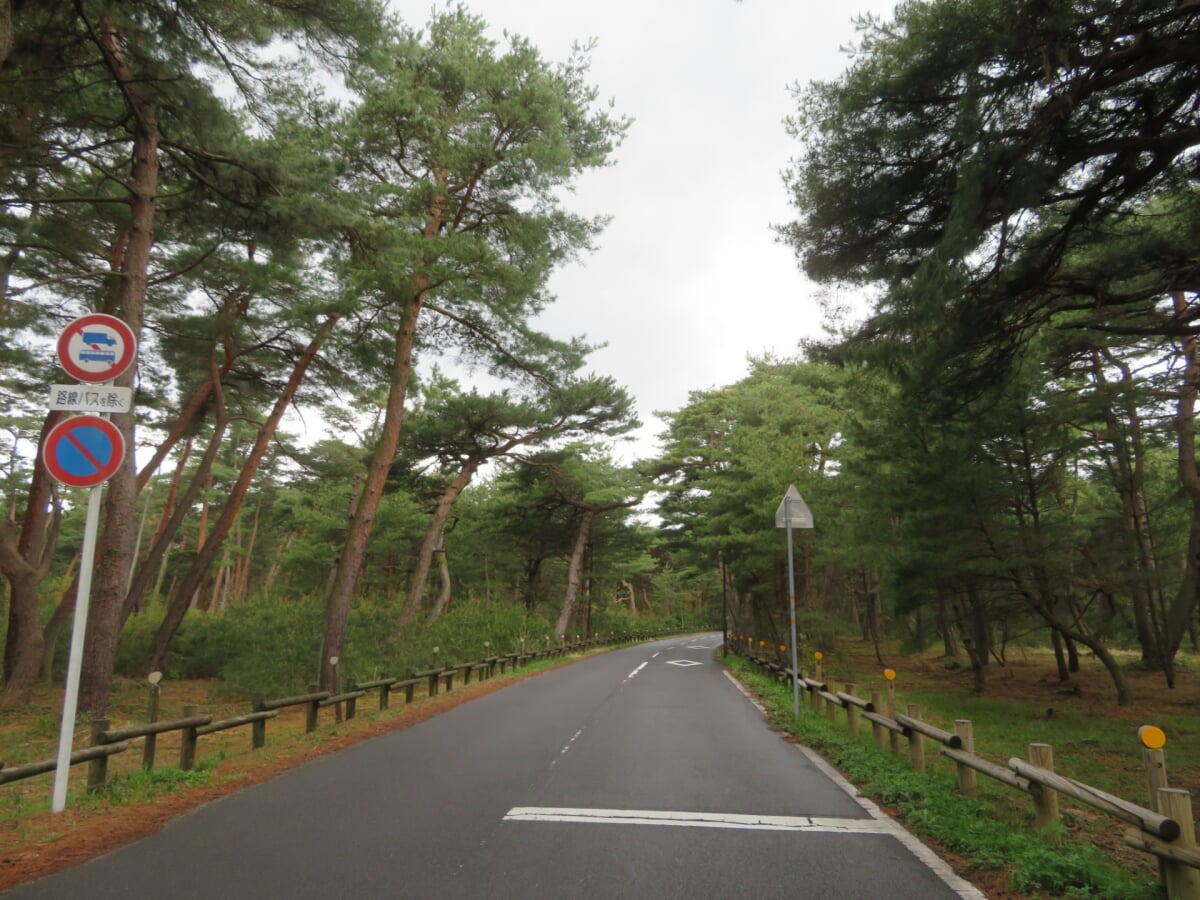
[392,0,893,461]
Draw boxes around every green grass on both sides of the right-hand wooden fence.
[730,642,1200,900]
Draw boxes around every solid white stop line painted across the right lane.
[504,806,892,834]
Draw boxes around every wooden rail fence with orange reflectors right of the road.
[728,640,1200,900]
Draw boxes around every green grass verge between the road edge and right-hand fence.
[728,656,1160,900]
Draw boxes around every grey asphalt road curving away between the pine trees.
[11,635,980,900]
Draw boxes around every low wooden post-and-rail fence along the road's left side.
[0,630,673,791]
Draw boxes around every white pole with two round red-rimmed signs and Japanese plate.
[42,313,137,812]
